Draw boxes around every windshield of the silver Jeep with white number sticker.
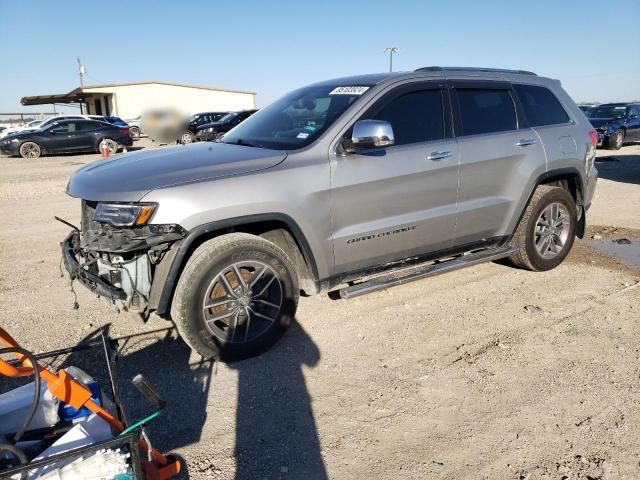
[223,85,369,150]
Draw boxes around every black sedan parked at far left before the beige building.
[0,119,133,158]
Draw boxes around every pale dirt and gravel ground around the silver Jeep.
[0,141,640,480]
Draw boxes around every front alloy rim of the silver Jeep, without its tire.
[202,261,283,343]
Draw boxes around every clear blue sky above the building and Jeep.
[0,0,640,112]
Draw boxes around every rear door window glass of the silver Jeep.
[456,88,517,135]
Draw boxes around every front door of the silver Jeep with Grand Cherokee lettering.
[331,82,459,274]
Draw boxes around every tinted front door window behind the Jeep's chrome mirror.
[371,90,444,145]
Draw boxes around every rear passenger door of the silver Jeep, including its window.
[450,80,546,247]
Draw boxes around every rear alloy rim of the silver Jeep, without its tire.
[533,202,571,259]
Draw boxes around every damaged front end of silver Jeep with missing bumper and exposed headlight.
[62,200,187,318]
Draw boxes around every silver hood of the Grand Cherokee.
[67,142,287,202]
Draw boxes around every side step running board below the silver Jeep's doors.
[340,246,518,299]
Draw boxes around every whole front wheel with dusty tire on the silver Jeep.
[171,233,299,360]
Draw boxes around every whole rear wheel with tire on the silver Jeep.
[510,185,577,272]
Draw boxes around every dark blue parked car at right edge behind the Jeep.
[586,103,640,150]
